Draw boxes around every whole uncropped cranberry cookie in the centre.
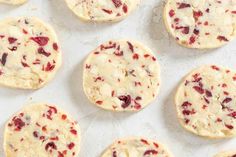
[83,40,160,111]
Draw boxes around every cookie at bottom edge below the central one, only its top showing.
[101,138,172,157]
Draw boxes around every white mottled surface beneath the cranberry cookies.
[0,0,236,157]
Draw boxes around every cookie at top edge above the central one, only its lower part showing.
[65,0,141,22]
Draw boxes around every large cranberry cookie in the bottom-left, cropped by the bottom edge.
[4,104,80,157]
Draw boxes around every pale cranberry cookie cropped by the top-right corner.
[163,0,236,49]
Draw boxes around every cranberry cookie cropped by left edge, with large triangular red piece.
[0,17,61,89]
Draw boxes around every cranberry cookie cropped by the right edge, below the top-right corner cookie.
[175,65,236,138]
